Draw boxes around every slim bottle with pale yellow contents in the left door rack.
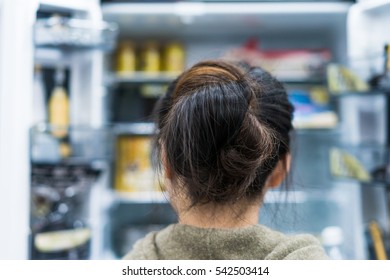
[49,68,71,157]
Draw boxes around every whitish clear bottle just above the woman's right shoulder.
[321,226,345,260]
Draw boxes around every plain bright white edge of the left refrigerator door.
[0,0,38,259]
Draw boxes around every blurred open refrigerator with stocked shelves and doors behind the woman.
[0,0,390,259]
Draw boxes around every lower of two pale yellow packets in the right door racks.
[330,148,371,182]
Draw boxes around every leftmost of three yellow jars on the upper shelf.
[116,40,136,75]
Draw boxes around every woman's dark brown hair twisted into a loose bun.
[155,61,293,206]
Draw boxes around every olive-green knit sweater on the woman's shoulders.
[124,224,328,260]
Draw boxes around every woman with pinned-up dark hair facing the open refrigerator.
[125,61,327,260]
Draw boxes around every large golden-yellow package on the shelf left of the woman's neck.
[115,135,158,192]
